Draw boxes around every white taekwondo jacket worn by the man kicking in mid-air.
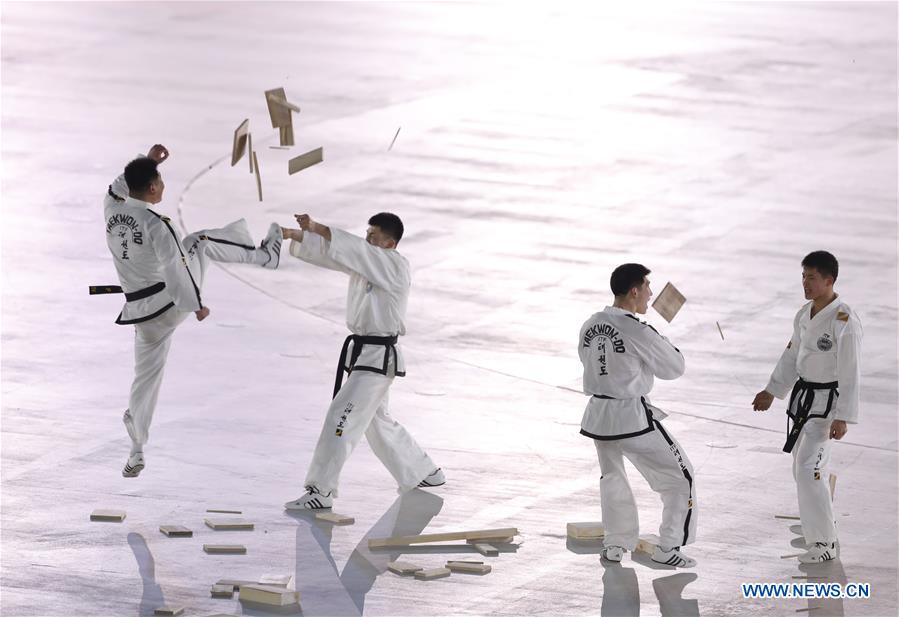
[104,175,203,325]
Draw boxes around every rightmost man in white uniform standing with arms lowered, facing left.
[752,251,863,563]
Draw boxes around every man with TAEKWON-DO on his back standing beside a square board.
[578,264,696,567]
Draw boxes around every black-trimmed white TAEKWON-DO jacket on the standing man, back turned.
[578,306,685,440]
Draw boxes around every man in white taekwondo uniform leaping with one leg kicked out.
[99,144,282,478]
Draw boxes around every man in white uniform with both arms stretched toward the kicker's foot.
[283,212,446,510]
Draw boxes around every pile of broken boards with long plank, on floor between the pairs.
[368,527,519,581]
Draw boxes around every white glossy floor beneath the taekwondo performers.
[0,2,899,617]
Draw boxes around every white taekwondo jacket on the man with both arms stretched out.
[290,227,412,377]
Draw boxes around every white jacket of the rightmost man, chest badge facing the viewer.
[765,297,863,424]
